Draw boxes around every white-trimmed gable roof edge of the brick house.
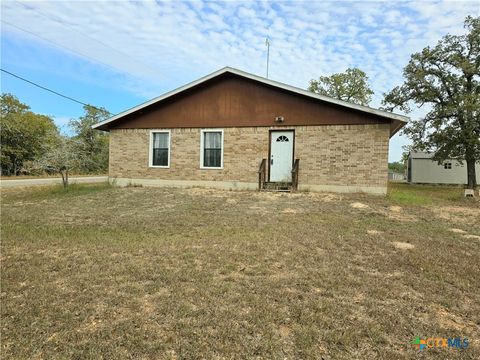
[93,67,409,136]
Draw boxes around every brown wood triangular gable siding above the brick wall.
[111,75,390,129]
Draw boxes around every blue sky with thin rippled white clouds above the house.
[1,0,480,161]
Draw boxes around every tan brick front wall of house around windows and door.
[109,124,389,187]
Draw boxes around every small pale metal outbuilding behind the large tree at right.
[407,151,480,185]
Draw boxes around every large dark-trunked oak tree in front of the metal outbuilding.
[383,16,480,189]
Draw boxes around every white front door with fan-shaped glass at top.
[270,131,294,182]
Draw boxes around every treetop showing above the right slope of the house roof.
[308,68,373,106]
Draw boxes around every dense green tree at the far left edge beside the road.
[0,94,58,175]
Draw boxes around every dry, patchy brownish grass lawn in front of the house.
[0,184,480,359]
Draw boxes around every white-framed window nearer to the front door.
[200,129,223,169]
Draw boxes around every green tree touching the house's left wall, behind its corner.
[70,106,110,173]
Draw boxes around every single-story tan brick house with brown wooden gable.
[94,67,408,194]
